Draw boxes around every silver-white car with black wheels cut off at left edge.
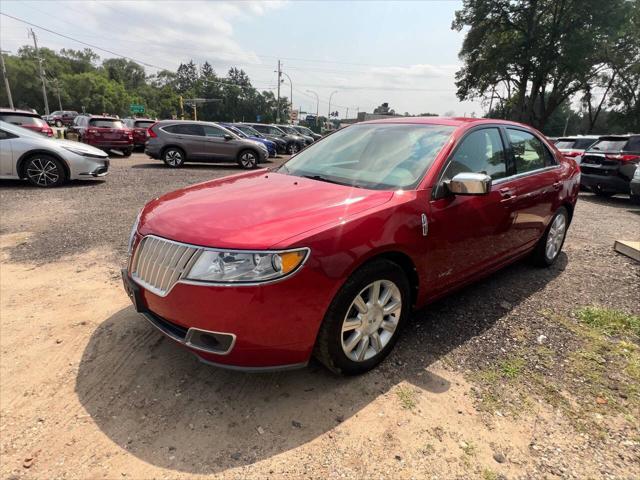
[0,121,109,187]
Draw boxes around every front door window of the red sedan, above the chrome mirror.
[444,128,507,180]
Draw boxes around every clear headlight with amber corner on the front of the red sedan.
[186,248,309,284]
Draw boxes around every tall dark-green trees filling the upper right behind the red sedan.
[452,0,640,134]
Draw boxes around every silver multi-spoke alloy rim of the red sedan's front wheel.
[341,280,402,362]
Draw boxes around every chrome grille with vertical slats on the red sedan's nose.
[131,235,200,297]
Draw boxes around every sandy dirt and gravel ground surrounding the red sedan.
[0,154,640,480]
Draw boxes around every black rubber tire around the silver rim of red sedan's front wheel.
[316,260,411,375]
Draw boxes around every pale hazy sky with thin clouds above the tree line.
[0,0,484,118]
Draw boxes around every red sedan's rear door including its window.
[496,127,562,252]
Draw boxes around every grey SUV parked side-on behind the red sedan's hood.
[144,120,269,169]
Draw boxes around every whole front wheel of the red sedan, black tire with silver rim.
[314,259,411,375]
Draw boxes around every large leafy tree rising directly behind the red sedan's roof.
[452,0,637,128]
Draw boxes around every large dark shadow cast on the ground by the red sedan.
[76,254,567,474]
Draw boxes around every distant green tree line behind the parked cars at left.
[0,46,289,122]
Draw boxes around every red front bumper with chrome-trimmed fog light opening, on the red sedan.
[122,249,337,371]
